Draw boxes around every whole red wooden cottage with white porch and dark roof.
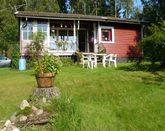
[15,11,143,60]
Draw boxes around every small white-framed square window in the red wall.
[99,26,114,43]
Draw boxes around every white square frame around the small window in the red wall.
[99,26,115,44]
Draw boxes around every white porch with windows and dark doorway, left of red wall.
[20,18,97,56]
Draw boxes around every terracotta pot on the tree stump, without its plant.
[36,73,55,88]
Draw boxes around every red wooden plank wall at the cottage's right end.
[104,25,141,57]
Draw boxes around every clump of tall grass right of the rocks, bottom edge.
[51,97,81,131]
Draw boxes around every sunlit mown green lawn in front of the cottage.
[0,64,165,131]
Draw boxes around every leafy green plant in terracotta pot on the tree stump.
[35,54,62,88]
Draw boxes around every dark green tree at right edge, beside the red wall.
[141,21,165,67]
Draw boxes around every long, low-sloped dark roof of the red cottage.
[15,11,145,25]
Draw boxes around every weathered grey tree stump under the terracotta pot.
[33,87,60,98]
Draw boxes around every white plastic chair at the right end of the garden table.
[105,54,117,67]
